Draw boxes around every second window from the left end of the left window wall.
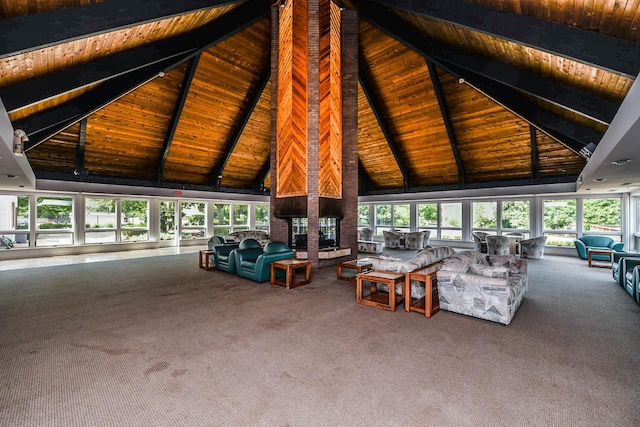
[36,196,74,246]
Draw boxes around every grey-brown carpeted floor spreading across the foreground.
[0,254,640,427]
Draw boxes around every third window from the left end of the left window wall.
[84,197,117,244]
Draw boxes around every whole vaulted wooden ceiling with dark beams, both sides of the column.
[0,0,640,194]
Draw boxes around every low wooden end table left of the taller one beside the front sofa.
[356,270,405,311]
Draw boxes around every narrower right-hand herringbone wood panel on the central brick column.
[318,0,342,199]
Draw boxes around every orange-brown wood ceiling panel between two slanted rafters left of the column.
[164,19,270,185]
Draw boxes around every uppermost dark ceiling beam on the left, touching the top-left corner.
[0,0,244,59]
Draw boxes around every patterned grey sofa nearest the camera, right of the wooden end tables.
[437,251,528,325]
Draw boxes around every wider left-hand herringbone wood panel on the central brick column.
[276,0,308,197]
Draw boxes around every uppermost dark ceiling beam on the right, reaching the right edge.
[359,0,640,79]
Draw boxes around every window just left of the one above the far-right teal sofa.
[543,199,578,246]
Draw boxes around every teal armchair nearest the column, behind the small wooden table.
[234,241,293,283]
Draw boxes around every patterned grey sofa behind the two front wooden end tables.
[371,246,455,299]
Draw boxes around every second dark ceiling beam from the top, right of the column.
[362,3,620,125]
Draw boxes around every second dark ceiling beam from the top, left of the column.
[0,0,269,112]
